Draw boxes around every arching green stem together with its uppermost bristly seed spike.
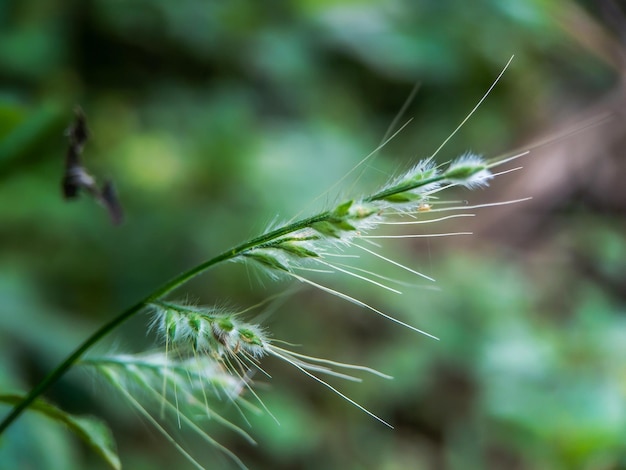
[0,58,520,435]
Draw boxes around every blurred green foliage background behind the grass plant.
[0,0,626,470]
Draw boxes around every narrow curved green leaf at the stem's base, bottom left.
[0,394,122,470]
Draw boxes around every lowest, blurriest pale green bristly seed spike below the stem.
[81,352,258,469]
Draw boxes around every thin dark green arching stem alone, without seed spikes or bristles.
[0,212,330,435]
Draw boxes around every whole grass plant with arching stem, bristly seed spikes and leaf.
[0,57,527,468]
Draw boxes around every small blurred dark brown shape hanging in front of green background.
[62,107,124,225]
